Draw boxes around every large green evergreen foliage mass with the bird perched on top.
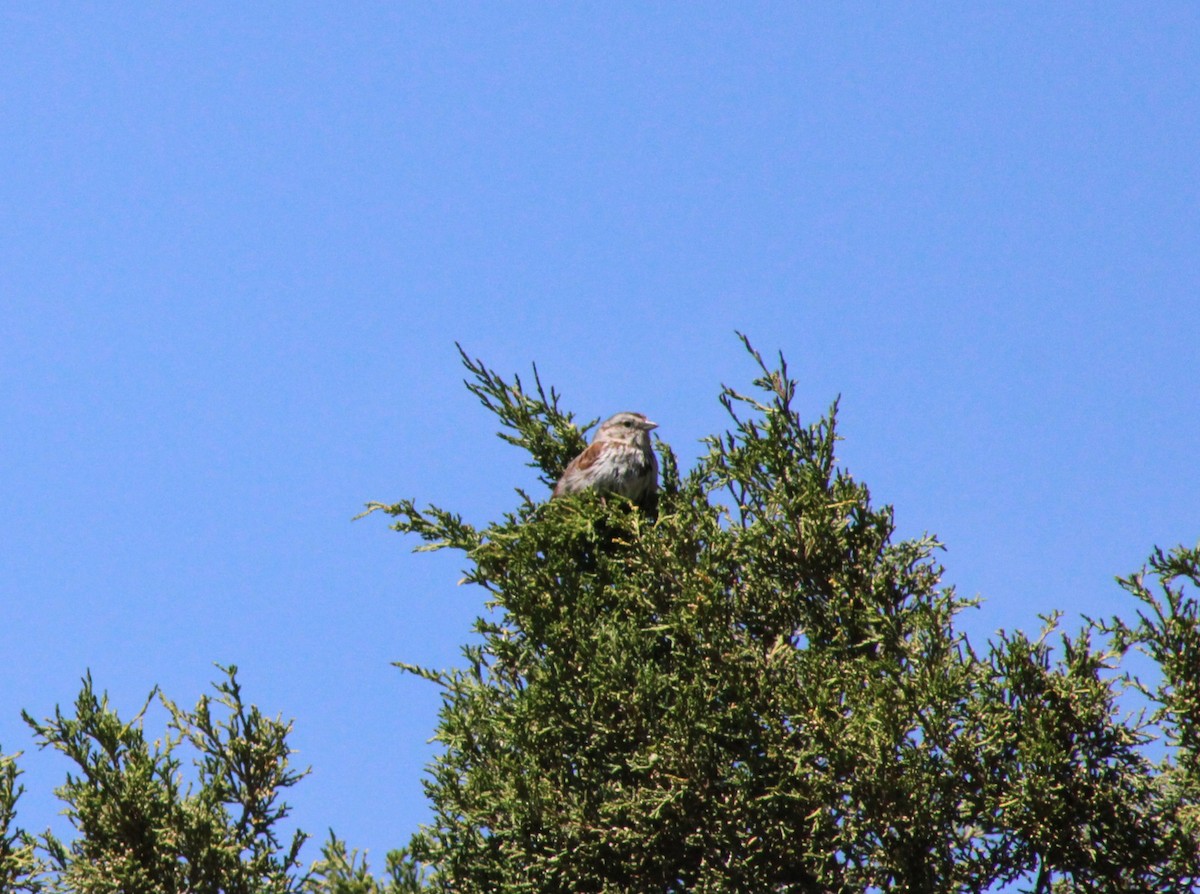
[367,343,1200,893]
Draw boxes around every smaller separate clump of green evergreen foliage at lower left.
[19,667,305,894]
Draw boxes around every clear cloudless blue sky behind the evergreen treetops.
[0,2,1200,863]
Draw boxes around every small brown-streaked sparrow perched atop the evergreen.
[552,413,659,508]
